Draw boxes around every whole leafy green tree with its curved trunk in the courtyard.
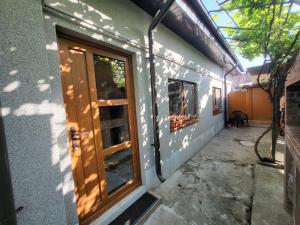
[221,0,300,163]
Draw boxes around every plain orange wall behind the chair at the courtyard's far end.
[228,87,272,121]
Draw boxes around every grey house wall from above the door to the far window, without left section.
[45,0,223,183]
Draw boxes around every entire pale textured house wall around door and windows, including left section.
[0,0,224,224]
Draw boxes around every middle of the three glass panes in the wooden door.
[99,105,130,149]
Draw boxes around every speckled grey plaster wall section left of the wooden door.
[0,0,67,225]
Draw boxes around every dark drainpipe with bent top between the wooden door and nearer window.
[148,0,175,182]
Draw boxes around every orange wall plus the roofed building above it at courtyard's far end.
[228,64,272,124]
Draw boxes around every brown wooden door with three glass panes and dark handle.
[59,38,140,224]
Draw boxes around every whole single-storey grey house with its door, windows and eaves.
[0,0,240,225]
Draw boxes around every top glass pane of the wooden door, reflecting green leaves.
[94,55,127,99]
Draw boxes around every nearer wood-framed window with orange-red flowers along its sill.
[168,79,197,131]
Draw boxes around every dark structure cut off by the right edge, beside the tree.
[284,51,300,225]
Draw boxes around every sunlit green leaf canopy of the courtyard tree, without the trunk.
[223,0,300,61]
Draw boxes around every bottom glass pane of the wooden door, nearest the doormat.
[105,148,133,194]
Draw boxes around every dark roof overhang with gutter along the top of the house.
[131,0,244,75]
